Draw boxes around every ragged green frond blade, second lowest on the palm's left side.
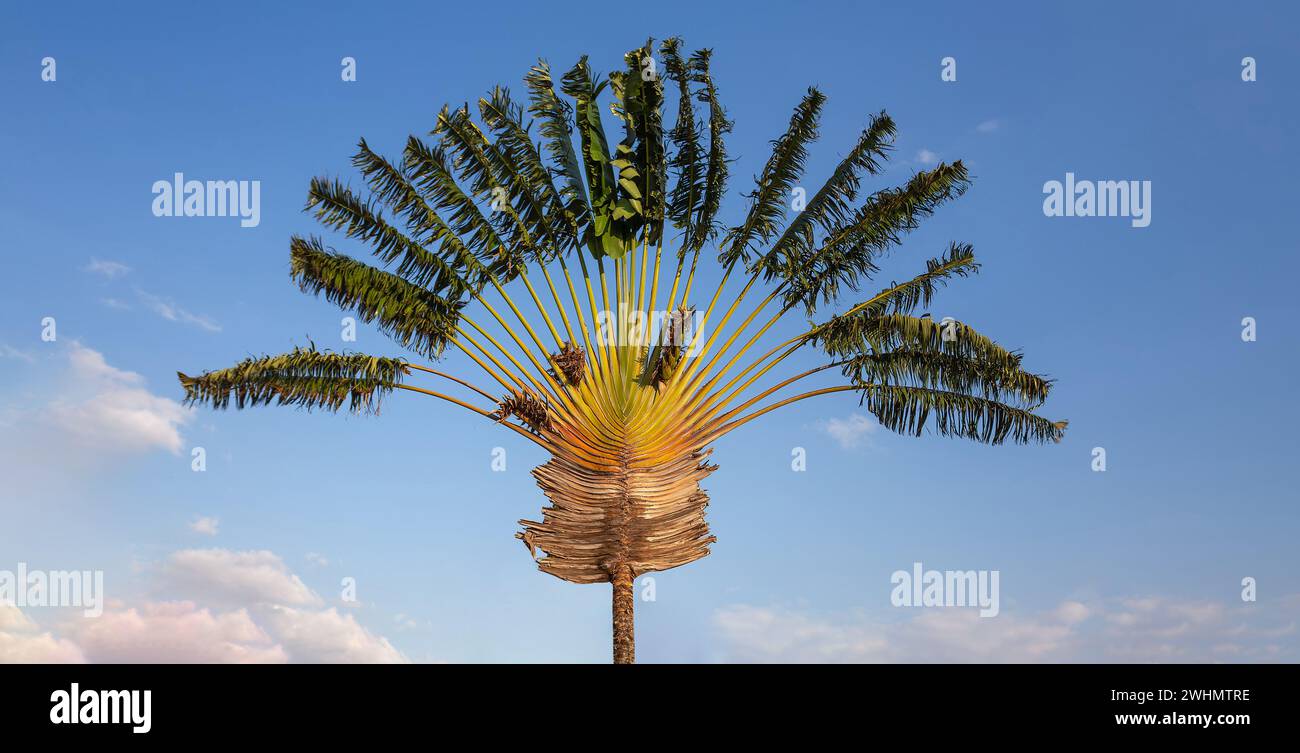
[290,235,464,358]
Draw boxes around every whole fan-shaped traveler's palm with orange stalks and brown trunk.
[179,39,1065,662]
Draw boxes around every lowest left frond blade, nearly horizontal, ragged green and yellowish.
[177,345,410,412]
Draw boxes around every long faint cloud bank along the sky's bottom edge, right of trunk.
[714,598,1300,662]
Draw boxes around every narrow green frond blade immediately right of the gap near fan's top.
[718,87,826,267]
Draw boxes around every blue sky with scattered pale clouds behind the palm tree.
[0,3,1300,662]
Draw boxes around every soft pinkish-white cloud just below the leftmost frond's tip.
[44,342,192,454]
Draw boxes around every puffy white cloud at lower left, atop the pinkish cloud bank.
[160,549,322,606]
